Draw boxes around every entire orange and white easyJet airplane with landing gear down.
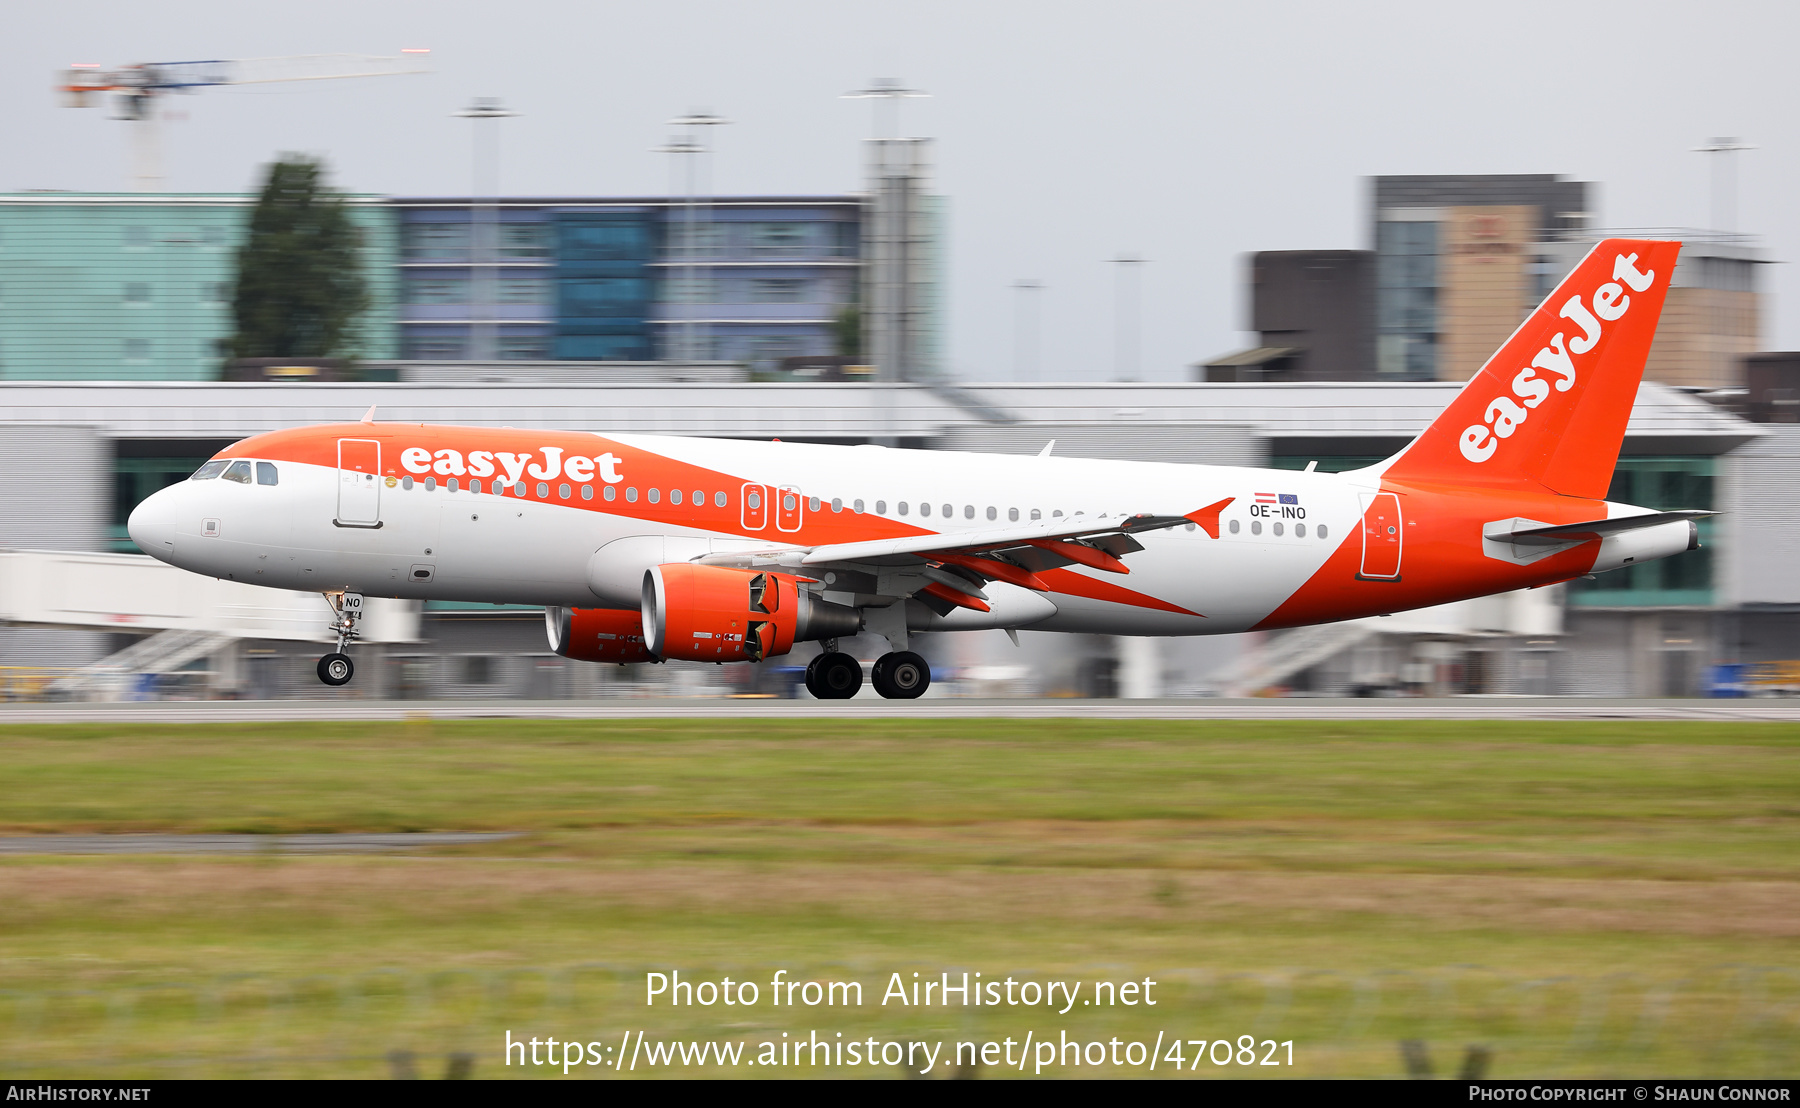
[130,239,1708,700]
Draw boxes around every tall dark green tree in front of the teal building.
[230,155,369,358]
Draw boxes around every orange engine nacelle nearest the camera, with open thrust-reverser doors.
[643,561,862,662]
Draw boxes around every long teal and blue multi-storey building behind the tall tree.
[0,180,943,381]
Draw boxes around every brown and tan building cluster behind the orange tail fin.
[1195,174,1766,389]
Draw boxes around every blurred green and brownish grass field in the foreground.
[0,721,1800,1076]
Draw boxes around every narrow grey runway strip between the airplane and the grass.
[0,696,1800,727]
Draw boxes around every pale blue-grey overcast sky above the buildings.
[0,0,1800,380]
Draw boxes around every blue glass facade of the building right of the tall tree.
[394,200,860,371]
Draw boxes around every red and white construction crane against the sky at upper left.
[58,50,430,192]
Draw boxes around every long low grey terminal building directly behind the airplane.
[0,375,1800,698]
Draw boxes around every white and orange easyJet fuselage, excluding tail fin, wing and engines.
[123,423,1670,635]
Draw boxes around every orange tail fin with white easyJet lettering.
[1384,239,1681,498]
